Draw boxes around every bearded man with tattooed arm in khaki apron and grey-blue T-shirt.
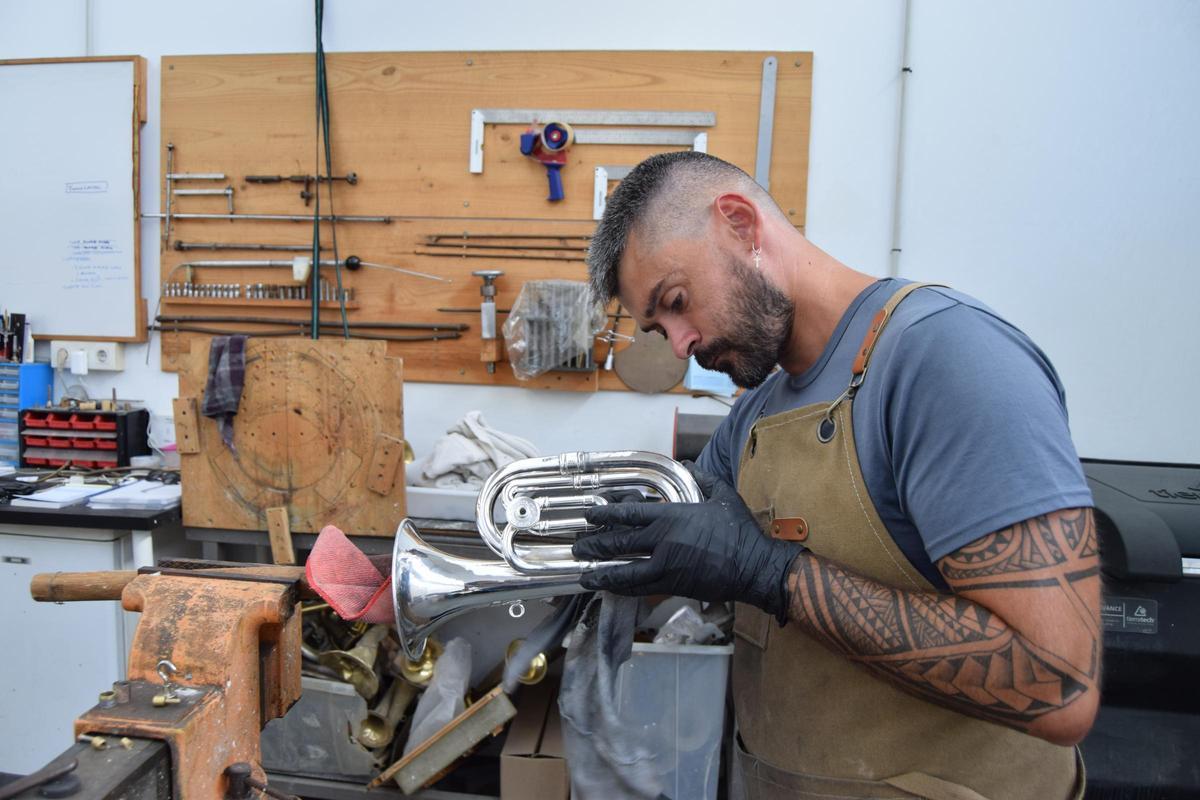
[574,152,1100,800]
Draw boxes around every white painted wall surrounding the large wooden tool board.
[0,0,1200,461]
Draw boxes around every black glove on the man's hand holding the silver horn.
[571,463,804,622]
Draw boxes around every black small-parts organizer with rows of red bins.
[20,409,150,469]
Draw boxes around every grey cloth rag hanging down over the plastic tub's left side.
[558,593,662,800]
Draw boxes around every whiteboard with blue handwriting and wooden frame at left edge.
[0,55,146,342]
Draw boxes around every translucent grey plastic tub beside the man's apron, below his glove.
[617,642,733,800]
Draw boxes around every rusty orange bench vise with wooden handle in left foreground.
[25,565,307,800]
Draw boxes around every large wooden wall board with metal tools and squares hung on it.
[160,52,812,391]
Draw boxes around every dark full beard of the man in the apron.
[694,260,796,389]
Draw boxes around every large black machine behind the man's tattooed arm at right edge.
[1082,458,1200,800]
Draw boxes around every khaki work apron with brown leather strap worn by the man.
[732,283,1084,800]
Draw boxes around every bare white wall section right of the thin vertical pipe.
[900,0,1200,463]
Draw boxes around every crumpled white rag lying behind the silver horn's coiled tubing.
[409,411,538,489]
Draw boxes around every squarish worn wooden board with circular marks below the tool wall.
[179,338,404,536]
